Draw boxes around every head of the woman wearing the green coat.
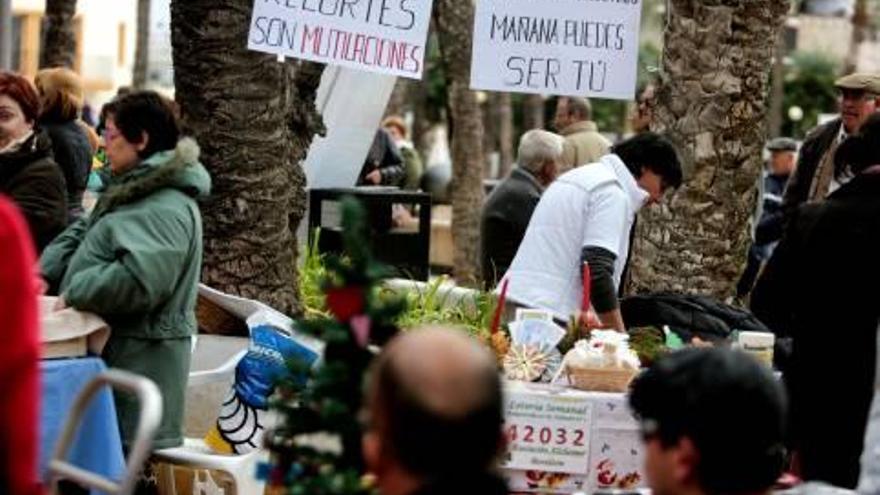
[104,91,180,174]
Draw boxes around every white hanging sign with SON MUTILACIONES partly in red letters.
[248,0,432,79]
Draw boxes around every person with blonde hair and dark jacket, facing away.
[34,68,92,222]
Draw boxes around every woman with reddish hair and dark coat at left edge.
[0,72,67,251]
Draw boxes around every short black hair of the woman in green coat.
[113,91,180,158]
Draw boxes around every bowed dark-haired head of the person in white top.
[611,132,682,204]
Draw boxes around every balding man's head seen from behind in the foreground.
[363,328,507,495]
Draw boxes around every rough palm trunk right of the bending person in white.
[632,0,789,299]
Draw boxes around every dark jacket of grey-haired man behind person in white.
[480,167,543,287]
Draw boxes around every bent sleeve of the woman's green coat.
[63,209,194,315]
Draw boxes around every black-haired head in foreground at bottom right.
[630,348,786,495]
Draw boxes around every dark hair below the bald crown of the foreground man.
[373,348,504,480]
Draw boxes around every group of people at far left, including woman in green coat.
[0,69,211,493]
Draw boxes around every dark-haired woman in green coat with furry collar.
[40,92,211,449]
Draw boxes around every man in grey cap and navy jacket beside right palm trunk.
[736,138,797,298]
